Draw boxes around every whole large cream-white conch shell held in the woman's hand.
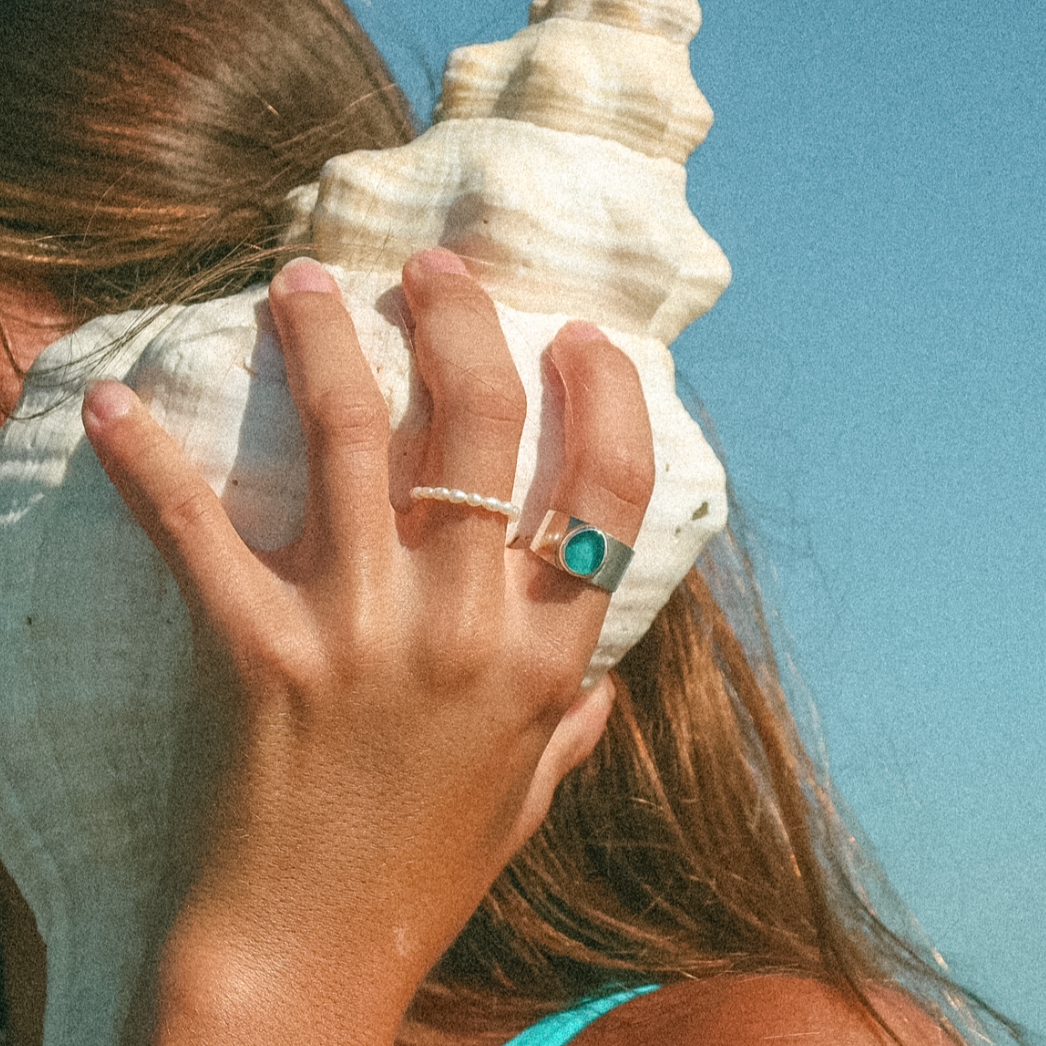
[0,0,730,1046]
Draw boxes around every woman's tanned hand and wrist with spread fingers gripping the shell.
[84,251,653,1046]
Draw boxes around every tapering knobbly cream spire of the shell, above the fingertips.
[282,0,730,344]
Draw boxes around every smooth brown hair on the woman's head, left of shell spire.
[0,0,413,320]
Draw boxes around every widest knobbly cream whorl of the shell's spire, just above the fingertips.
[305,117,729,341]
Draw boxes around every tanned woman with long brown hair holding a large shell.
[0,0,1029,1043]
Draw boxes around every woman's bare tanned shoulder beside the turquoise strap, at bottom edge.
[571,974,952,1046]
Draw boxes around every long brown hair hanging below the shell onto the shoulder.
[402,523,1025,1046]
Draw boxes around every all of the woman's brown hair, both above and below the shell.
[0,0,1029,1044]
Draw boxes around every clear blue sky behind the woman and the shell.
[353,0,1046,1036]
